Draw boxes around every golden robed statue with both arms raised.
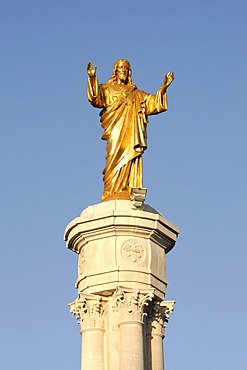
[87,59,174,201]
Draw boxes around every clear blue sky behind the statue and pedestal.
[0,0,247,370]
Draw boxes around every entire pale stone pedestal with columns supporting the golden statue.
[65,200,179,370]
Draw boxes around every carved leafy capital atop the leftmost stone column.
[69,294,107,332]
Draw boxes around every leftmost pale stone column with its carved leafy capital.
[69,295,105,370]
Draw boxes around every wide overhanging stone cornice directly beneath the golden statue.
[64,200,179,253]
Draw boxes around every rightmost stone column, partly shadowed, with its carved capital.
[145,301,175,370]
